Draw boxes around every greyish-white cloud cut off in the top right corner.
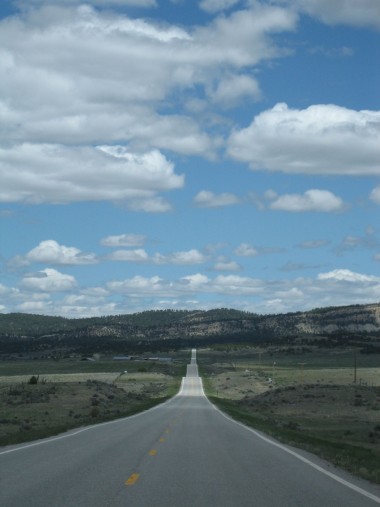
[290,0,380,28]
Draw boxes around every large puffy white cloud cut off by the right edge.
[228,104,380,176]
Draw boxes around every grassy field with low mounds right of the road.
[197,349,380,483]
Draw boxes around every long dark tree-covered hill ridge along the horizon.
[0,304,380,356]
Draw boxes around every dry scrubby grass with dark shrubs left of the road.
[0,372,179,445]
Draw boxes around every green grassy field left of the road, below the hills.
[0,358,188,445]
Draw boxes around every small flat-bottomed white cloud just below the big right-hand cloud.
[270,189,344,213]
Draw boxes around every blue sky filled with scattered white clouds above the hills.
[0,0,380,318]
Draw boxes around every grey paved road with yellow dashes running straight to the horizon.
[0,350,380,507]
